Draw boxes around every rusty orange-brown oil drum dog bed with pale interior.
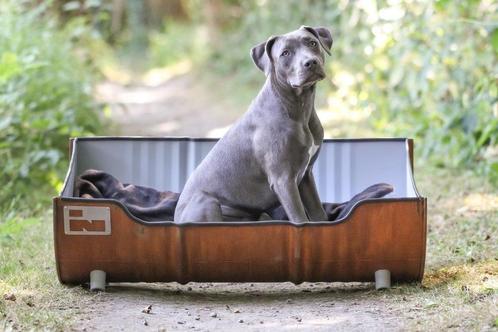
[53,137,427,284]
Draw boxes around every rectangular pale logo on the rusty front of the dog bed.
[64,206,111,235]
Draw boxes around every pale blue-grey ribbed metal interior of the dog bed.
[61,137,419,202]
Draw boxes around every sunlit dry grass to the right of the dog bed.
[402,165,498,330]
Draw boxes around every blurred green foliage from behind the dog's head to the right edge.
[204,0,498,185]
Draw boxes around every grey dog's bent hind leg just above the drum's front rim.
[175,192,223,222]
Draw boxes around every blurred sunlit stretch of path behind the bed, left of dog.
[97,74,245,137]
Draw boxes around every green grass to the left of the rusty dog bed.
[0,214,91,330]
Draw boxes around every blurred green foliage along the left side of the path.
[0,0,100,208]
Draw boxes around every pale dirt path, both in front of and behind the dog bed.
[85,74,401,331]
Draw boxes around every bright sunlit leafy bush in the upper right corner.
[342,1,498,180]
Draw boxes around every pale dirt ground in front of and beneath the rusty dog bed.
[77,283,399,331]
